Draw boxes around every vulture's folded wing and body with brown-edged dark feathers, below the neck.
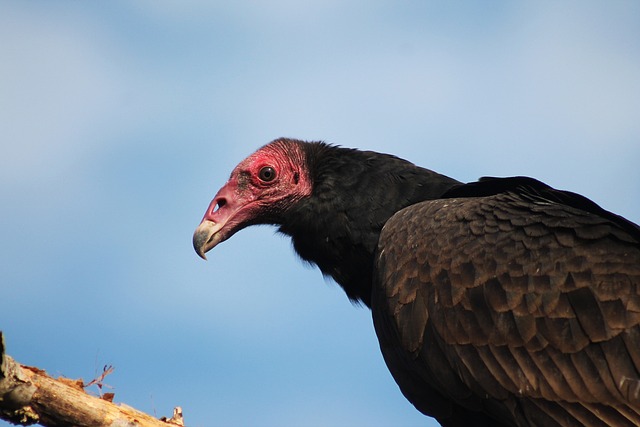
[372,180,640,426]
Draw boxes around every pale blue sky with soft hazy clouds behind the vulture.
[0,0,640,427]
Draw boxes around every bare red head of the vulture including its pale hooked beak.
[193,139,311,259]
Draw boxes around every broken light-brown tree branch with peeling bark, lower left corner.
[0,332,184,427]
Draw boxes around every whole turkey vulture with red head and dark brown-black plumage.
[193,138,640,427]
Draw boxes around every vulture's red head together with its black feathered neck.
[193,138,457,305]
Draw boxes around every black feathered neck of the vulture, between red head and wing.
[280,143,460,307]
